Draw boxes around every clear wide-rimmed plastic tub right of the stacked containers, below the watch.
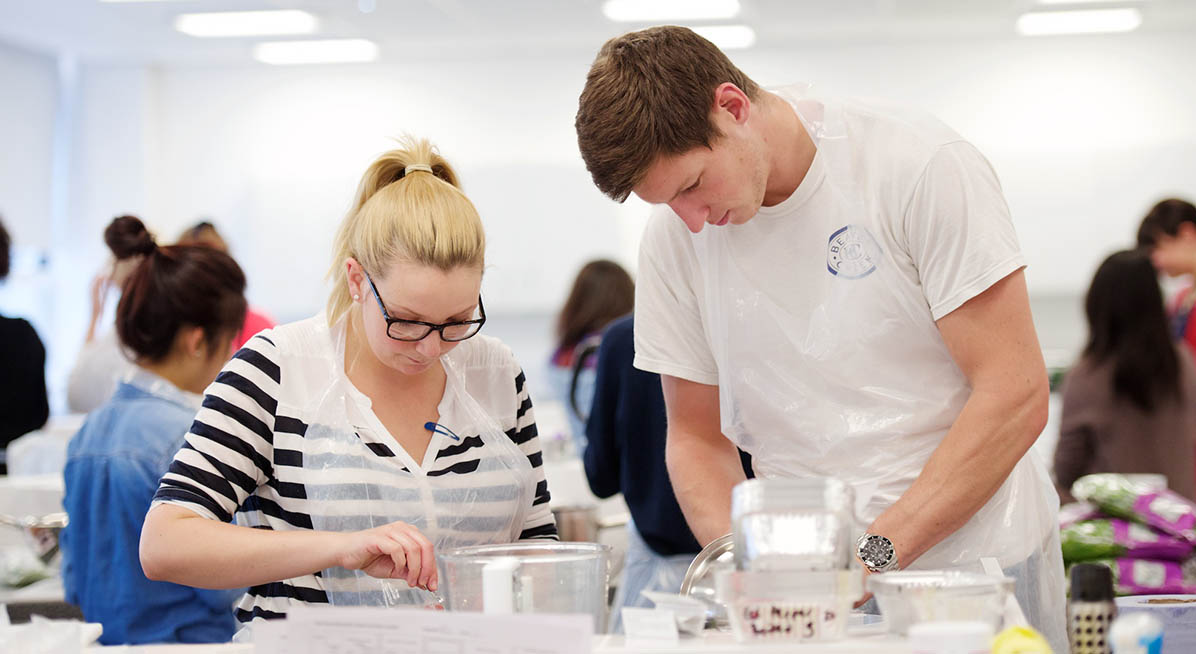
[865,570,1013,635]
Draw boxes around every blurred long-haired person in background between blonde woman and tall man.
[548,259,635,456]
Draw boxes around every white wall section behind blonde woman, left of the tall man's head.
[133,55,639,317]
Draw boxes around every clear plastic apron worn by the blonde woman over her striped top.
[280,322,536,606]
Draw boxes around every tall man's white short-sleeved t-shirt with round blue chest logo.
[635,88,1041,567]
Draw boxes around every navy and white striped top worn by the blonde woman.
[154,314,556,622]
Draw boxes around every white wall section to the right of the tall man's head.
[738,35,1196,294]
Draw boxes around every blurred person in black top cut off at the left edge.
[0,215,50,466]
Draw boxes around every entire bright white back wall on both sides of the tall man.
[16,29,1196,408]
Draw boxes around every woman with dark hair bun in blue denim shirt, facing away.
[61,218,245,644]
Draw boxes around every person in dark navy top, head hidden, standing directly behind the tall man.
[584,316,752,632]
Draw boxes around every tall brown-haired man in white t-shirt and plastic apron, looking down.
[576,26,1067,650]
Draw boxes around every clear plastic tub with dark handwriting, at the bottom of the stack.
[715,569,864,642]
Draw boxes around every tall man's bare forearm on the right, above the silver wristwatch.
[868,381,1048,567]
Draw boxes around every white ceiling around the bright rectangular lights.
[0,0,1196,66]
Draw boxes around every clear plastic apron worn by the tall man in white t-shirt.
[688,87,1067,652]
